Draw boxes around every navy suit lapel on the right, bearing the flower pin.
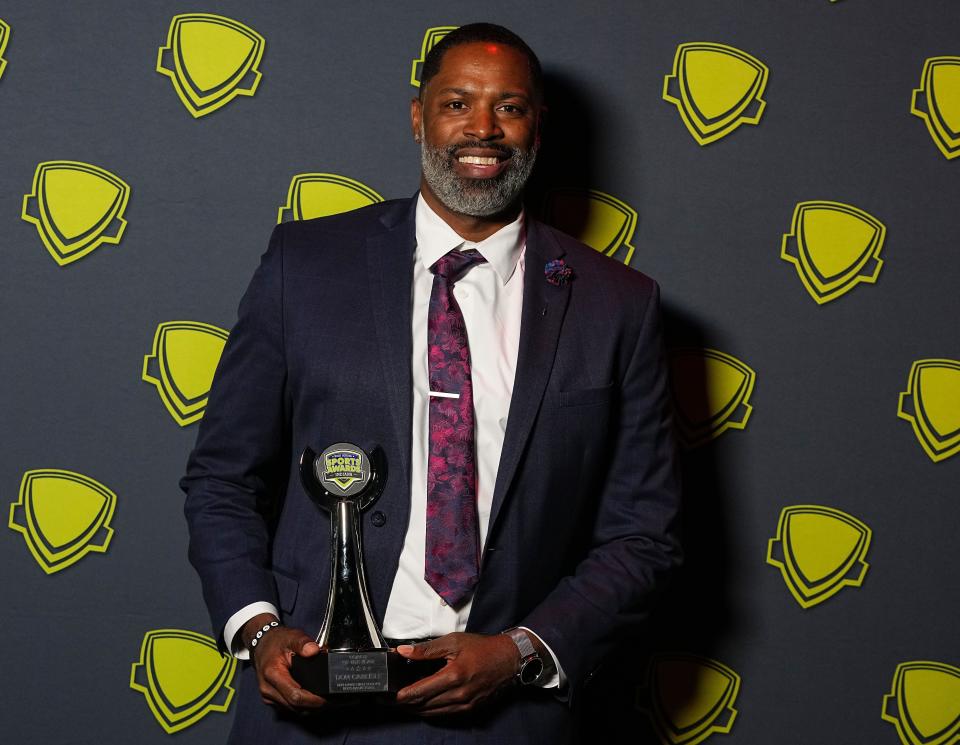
[490,220,570,531]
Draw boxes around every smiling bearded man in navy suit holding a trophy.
[182,24,679,743]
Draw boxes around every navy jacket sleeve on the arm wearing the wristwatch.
[521,284,681,702]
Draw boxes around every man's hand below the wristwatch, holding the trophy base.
[397,633,520,716]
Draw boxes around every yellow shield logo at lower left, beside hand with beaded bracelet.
[130,629,237,734]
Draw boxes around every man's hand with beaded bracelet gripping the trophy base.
[240,614,326,712]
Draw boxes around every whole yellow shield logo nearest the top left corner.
[157,13,266,119]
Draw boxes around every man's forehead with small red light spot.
[427,42,533,96]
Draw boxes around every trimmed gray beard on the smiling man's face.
[420,138,537,217]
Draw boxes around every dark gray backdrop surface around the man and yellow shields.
[0,0,960,745]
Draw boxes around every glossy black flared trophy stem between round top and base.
[317,500,387,652]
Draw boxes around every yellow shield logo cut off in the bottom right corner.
[881,660,960,745]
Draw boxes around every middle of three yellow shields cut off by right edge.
[897,359,960,463]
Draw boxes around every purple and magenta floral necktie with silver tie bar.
[424,249,486,607]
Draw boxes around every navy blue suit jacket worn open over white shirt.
[182,199,679,743]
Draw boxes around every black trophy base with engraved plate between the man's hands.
[290,649,445,703]
